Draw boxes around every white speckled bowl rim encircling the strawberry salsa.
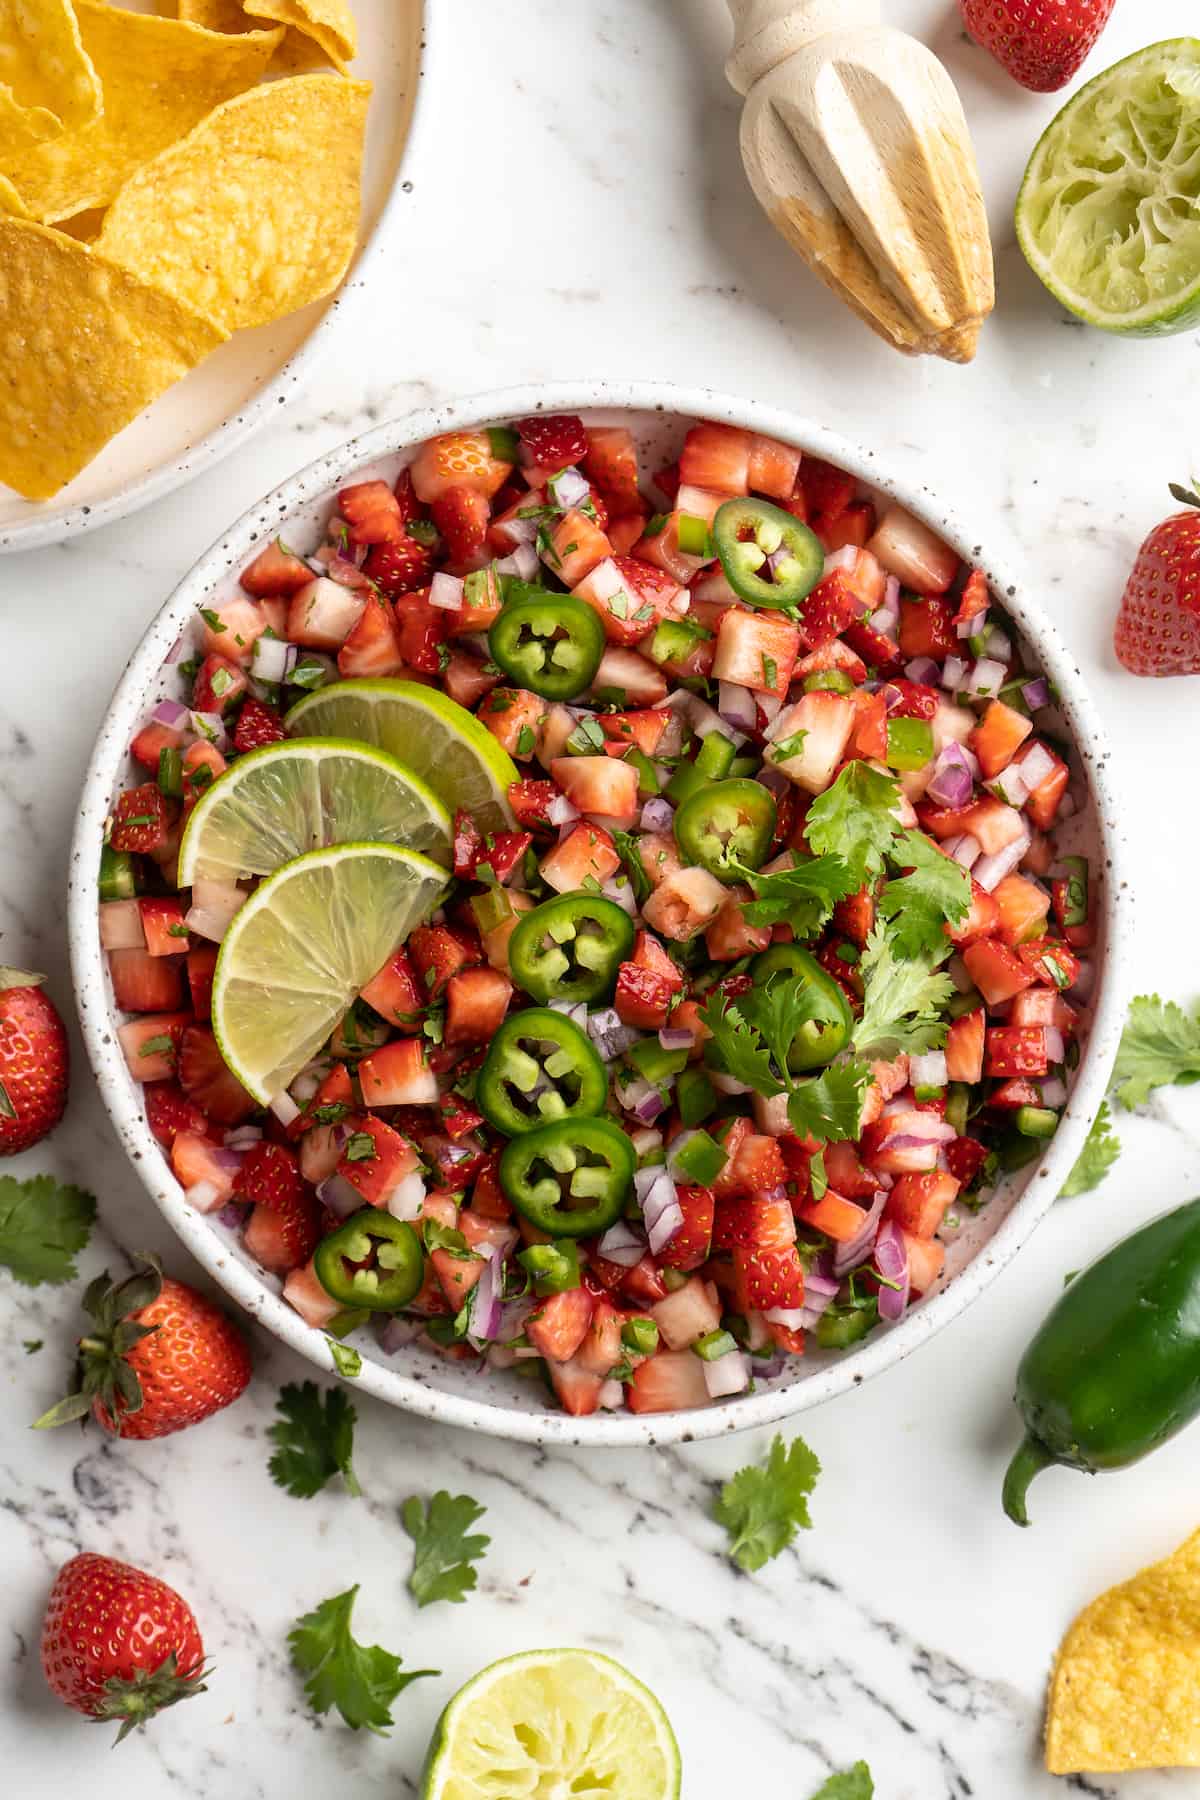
[68,382,1130,1445]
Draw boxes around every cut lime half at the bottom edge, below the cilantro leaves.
[421,1651,680,1800]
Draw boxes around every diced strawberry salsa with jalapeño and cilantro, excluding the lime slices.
[101,416,1094,1415]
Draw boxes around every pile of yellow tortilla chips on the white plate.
[0,0,371,500]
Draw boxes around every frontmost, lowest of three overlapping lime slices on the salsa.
[212,844,446,1105]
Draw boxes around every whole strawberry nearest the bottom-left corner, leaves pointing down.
[41,1552,205,1742]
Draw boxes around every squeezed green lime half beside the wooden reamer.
[1016,38,1200,337]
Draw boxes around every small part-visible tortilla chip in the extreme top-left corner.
[0,0,101,157]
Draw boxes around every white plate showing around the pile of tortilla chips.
[0,0,428,554]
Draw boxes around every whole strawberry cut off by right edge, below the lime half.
[1112,484,1200,675]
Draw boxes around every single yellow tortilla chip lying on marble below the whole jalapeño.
[1045,1532,1200,1775]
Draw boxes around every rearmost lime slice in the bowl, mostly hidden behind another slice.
[286,680,520,832]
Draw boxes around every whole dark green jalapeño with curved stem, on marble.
[1004,1201,1200,1525]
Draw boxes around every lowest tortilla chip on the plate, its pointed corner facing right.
[0,214,223,500]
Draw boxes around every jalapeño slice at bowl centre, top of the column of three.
[509,893,633,1004]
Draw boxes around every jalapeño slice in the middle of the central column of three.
[475,1006,608,1138]
